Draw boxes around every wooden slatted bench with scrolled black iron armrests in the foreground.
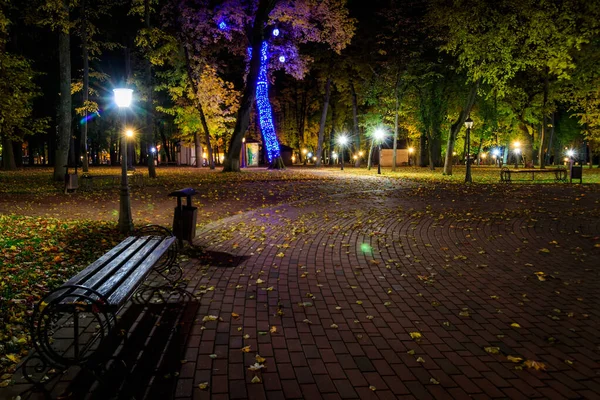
[22,226,191,397]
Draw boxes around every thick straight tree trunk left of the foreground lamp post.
[53,0,71,181]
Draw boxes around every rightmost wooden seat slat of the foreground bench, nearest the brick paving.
[106,237,175,304]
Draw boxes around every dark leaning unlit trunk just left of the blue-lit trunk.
[223,0,278,172]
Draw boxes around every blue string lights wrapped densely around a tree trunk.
[256,42,281,163]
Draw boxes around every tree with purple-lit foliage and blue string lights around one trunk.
[176,0,355,172]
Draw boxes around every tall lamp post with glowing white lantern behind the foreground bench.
[113,89,133,233]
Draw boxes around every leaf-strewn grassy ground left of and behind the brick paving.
[0,166,600,387]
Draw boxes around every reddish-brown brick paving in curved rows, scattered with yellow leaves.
[5,173,600,400]
